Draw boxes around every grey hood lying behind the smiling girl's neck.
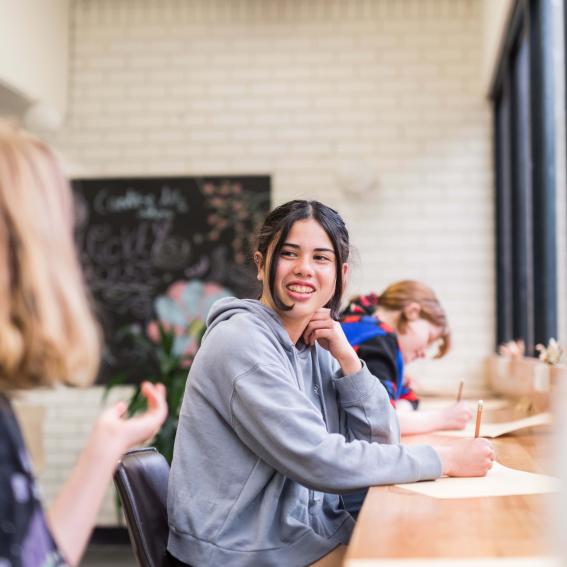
[203,297,294,349]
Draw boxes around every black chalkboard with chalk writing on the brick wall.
[72,176,270,382]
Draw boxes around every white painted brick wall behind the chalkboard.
[43,0,494,522]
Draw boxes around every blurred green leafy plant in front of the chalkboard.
[103,320,205,464]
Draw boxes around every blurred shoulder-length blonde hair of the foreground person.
[0,120,101,392]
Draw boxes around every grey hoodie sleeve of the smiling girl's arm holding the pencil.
[230,366,441,492]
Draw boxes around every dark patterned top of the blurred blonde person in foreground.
[0,394,67,567]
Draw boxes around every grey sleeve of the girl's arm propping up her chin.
[333,361,400,444]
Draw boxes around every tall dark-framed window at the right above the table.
[492,0,557,354]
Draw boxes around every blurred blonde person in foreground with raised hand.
[0,119,167,567]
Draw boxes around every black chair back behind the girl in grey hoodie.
[114,447,183,567]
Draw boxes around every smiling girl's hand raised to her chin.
[303,307,362,374]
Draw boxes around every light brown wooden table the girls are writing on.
[344,414,559,567]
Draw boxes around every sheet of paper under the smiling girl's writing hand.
[396,463,560,498]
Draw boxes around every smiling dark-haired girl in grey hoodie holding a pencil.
[168,201,494,567]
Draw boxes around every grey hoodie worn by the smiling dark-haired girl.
[168,298,441,567]
